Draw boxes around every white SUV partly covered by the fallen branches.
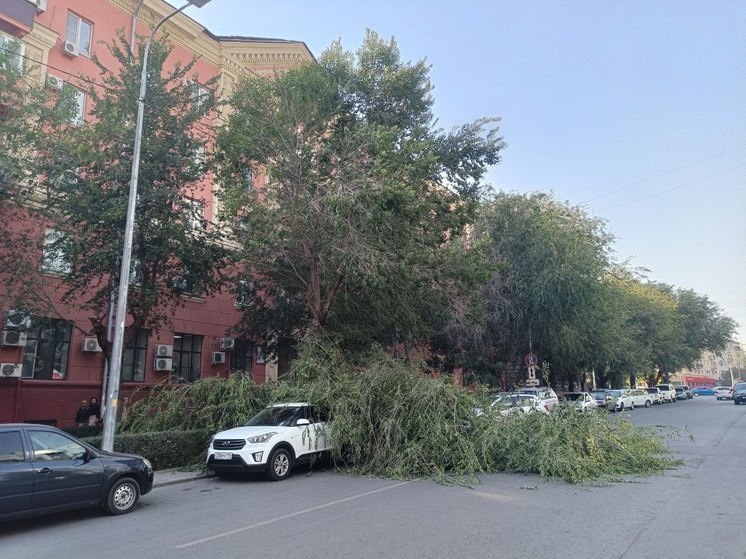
[207,402,331,481]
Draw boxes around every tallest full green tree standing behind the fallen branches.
[218,32,503,358]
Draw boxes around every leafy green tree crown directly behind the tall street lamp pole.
[44,32,231,351]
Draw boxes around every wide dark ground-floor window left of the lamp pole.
[21,317,72,380]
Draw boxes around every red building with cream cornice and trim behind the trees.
[0,0,313,427]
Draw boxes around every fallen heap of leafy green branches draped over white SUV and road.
[122,338,677,483]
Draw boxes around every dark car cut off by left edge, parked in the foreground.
[0,423,153,521]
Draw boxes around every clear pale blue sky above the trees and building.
[185,0,746,342]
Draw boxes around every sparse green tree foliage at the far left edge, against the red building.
[0,49,79,314]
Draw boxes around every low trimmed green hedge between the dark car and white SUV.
[84,429,213,470]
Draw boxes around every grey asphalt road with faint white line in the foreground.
[0,397,746,559]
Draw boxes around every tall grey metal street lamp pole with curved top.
[101,0,210,451]
